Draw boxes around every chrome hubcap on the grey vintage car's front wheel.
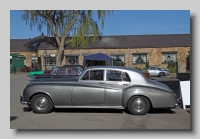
[35,97,49,110]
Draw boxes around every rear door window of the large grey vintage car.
[106,70,122,81]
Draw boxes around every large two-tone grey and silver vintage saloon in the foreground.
[20,66,179,115]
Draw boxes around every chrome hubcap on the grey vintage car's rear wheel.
[132,98,147,112]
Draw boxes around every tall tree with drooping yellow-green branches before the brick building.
[22,10,112,66]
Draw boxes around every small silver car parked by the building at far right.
[147,66,170,77]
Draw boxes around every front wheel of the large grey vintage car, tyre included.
[31,94,53,113]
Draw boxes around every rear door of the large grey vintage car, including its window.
[105,70,131,106]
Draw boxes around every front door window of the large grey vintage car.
[81,70,104,81]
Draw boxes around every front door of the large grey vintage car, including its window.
[72,69,105,106]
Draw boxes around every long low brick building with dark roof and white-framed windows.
[10,33,191,72]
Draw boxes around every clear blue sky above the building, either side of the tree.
[10,10,190,39]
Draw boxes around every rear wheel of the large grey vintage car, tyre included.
[128,96,150,115]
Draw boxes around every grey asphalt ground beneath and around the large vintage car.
[10,73,191,130]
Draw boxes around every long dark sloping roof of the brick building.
[10,34,191,51]
